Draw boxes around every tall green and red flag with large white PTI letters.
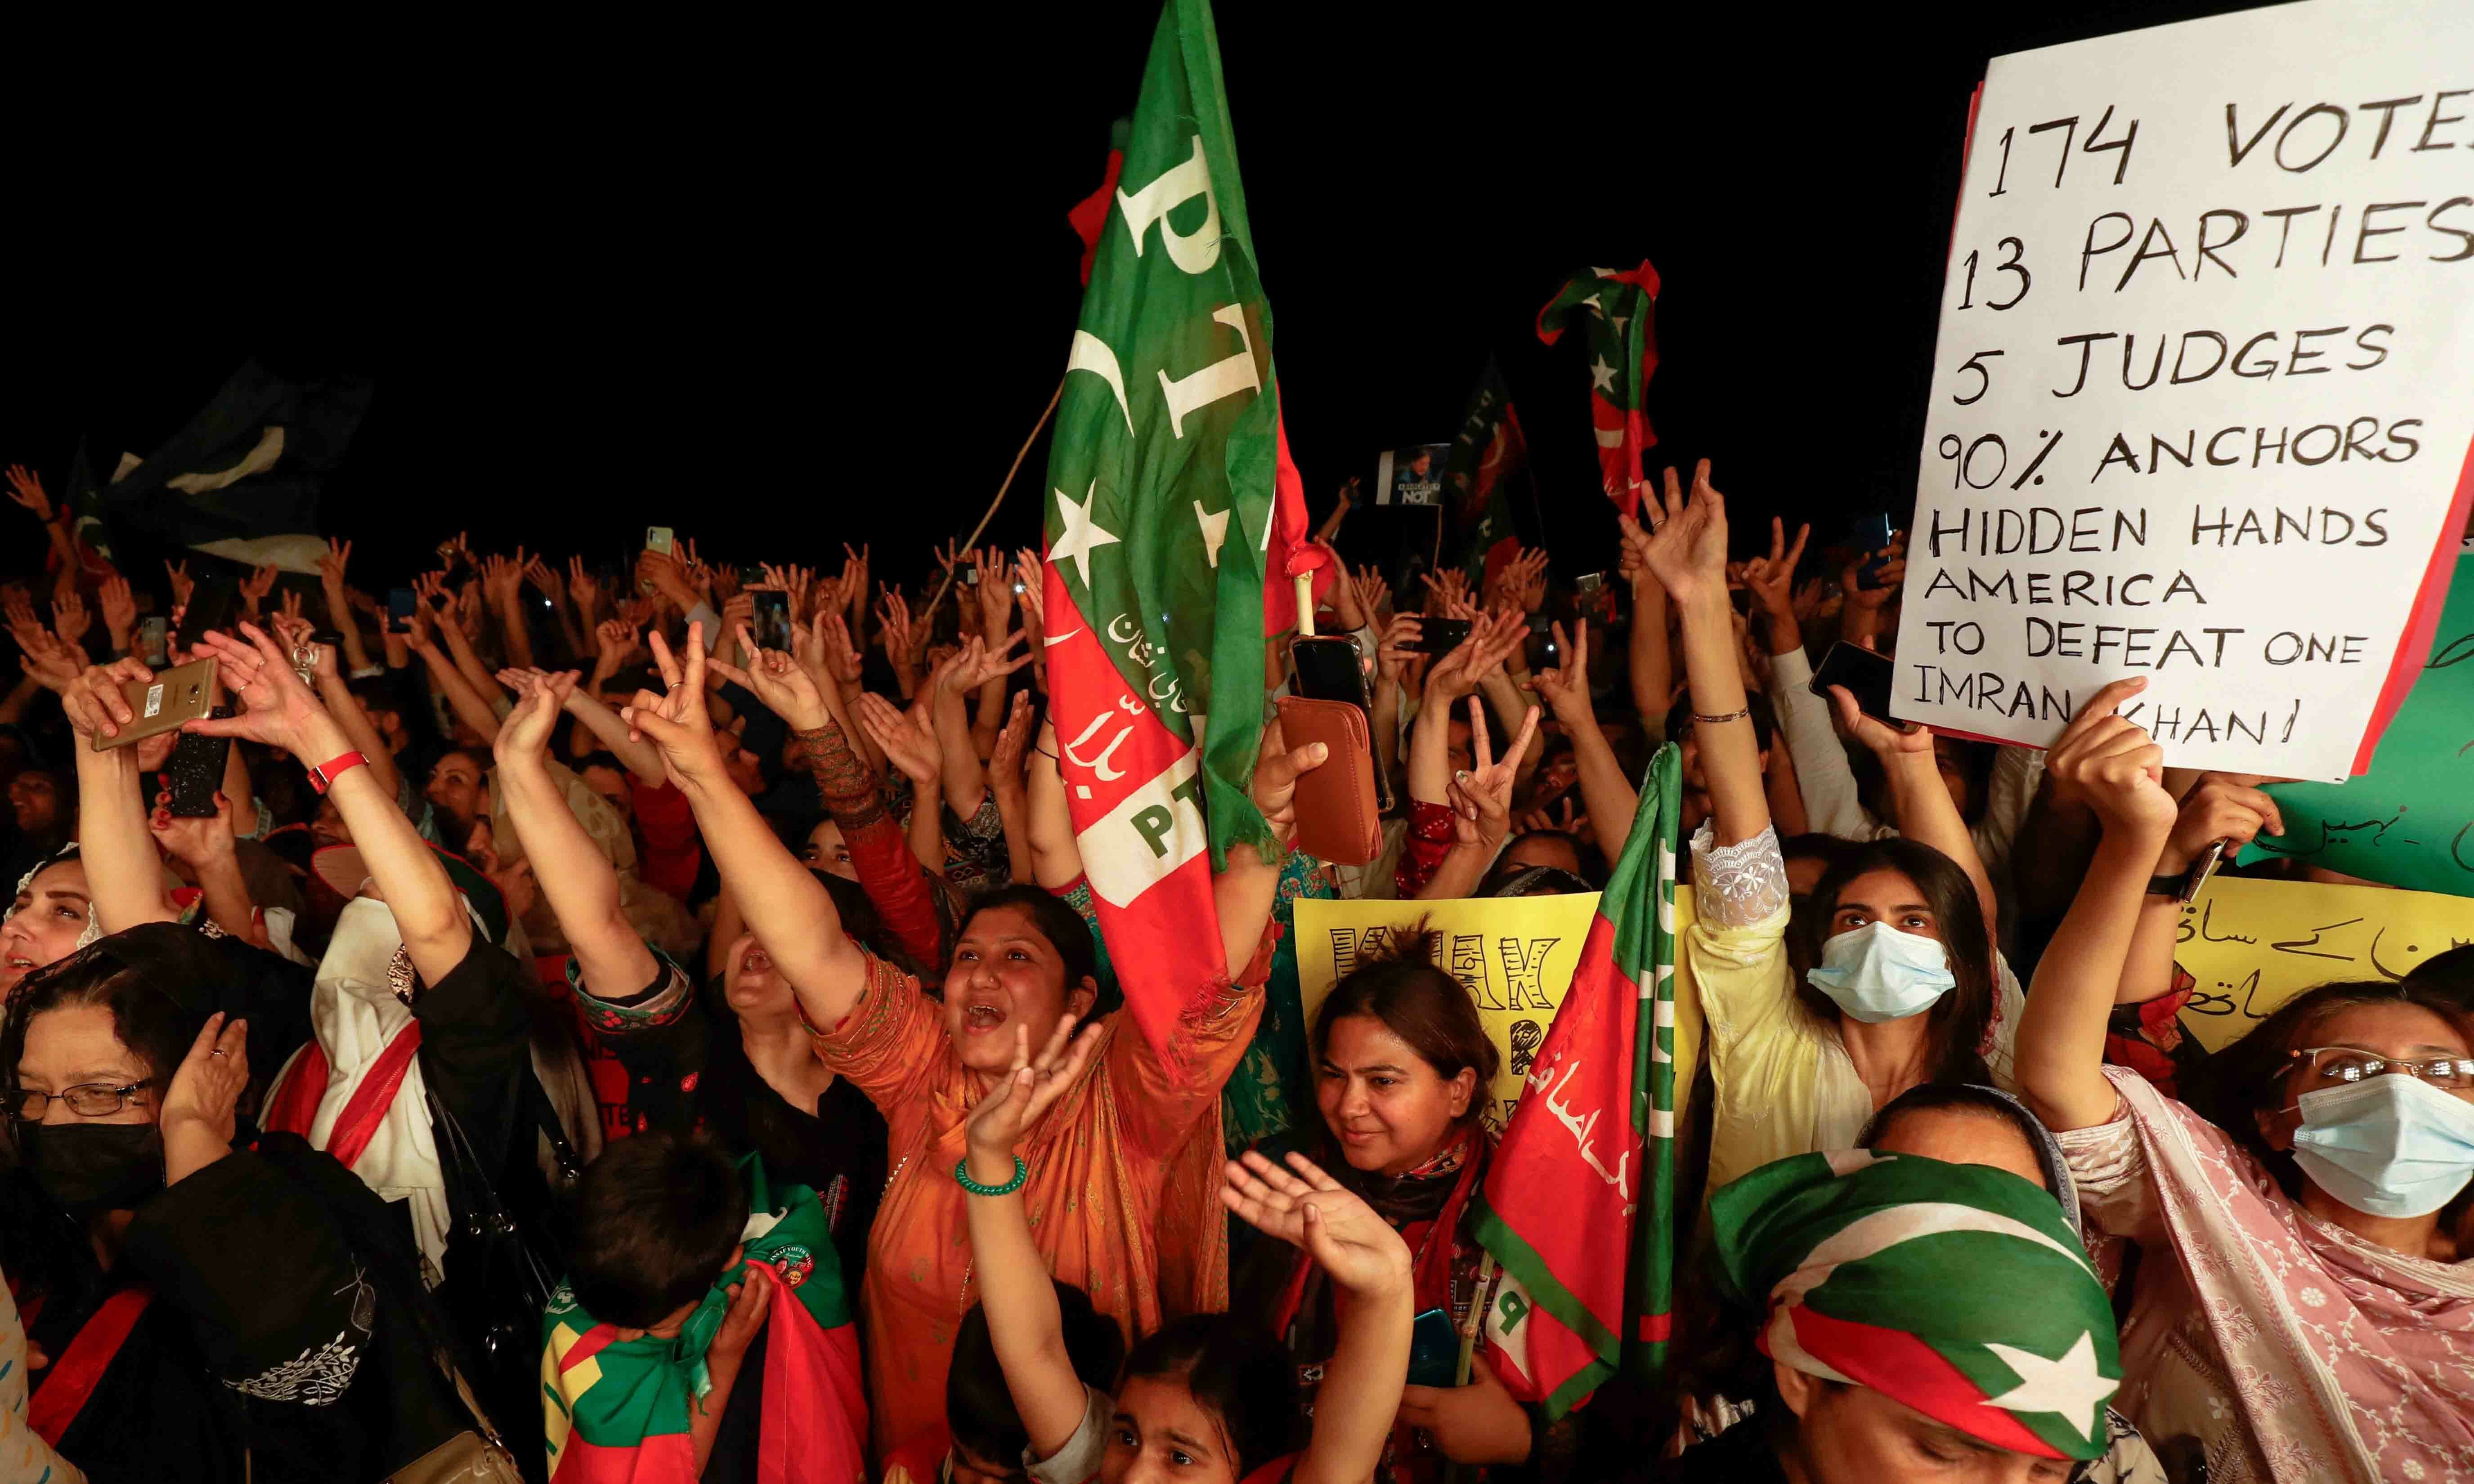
[1047,0,1319,1071]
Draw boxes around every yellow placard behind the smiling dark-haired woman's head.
[1296,885,1702,1135]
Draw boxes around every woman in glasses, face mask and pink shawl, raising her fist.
[2019,680,2474,1479]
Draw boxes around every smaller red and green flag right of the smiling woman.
[1477,742,1680,1417]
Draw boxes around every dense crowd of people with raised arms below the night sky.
[0,463,2474,1484]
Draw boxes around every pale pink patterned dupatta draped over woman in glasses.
[2106,1066,2474,1484]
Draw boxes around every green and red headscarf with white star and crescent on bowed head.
[1712,1148,2123,1459]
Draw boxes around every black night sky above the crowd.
[0,0,2241,586]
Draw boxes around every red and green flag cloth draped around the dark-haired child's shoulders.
[542,1155,869,1484]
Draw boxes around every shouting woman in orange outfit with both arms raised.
[611,626,1324,1449]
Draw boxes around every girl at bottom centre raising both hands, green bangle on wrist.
[955,1017,1413,1484]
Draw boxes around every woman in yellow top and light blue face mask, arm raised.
[1623,460,2021,1190]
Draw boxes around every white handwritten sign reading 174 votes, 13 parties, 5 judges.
[1893,0,2474,779]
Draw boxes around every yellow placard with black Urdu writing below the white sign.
[2172,876,2474,1051]
